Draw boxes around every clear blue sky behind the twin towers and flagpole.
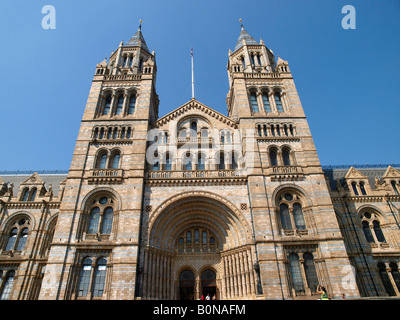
[0,0,400,171]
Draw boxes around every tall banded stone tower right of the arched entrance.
[227,25,358,298]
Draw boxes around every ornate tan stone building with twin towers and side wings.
[0,26,400,300]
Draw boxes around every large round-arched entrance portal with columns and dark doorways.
[141,195,257,300]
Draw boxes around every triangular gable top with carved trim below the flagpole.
[154,98,237,129]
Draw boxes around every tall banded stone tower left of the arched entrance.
[40,25,159,299]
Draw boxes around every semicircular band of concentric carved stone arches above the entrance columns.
[147,191,252,251]
